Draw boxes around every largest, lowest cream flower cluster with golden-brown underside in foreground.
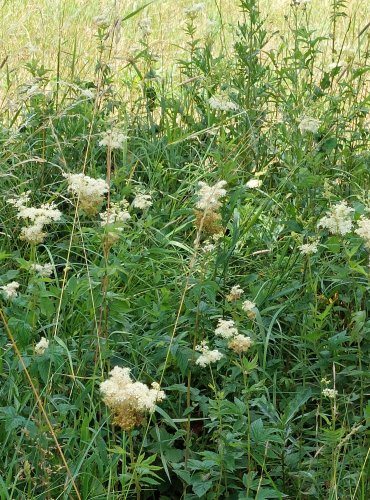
[100,366,166,431]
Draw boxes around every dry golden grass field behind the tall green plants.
[0,0,370,83]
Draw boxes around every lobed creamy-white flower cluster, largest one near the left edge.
[8,192,62,245]
